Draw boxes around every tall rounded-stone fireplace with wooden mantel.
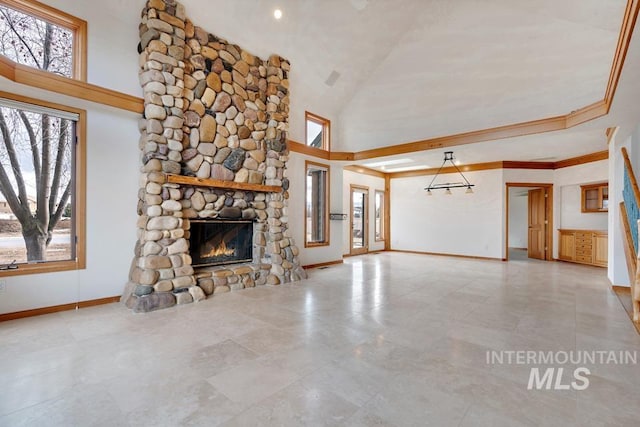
[123,0,305,312]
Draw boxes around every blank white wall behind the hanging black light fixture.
[391,170,504,259]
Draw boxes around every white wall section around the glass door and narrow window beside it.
[342,170,384,254]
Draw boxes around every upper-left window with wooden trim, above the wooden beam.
[0,0,87,81]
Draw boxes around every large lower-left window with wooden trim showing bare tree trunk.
[0,92,85,276]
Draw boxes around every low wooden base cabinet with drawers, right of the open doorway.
[558,230,608,267]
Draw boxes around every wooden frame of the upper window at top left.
[0,0,87,82]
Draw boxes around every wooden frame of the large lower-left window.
[0,91,87,277]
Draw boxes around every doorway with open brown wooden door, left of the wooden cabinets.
[505,183,553,261]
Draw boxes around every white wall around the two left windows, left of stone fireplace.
[0,0,140,313]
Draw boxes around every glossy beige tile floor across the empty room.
[0,253,640,426]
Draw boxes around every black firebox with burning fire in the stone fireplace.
[189,220,253,267]
